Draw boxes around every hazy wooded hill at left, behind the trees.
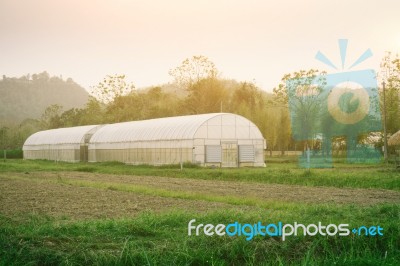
[0,72,89,123]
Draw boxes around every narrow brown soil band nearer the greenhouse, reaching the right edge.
[56,172,400,206]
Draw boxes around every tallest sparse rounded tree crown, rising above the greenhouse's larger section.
[169,55,218,89]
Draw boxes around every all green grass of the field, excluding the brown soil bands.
[0,160,400,265]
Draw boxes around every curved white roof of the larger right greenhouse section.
[90,113,264,143]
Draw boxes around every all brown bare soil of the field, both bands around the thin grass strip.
[0,172,400,219]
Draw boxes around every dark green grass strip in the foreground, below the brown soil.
[0,205,400,265]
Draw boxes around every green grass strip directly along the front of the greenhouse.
[0,160,400,191]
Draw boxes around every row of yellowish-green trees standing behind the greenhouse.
[0,53,400,156]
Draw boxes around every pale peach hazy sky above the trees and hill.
[0,0,400,91]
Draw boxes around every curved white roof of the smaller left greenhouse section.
[24,125,97,146]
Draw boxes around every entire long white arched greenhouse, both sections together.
[24,113,266,167]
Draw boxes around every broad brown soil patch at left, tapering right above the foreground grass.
[0,173,230,219]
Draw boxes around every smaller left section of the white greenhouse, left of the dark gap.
[22,126,101,162]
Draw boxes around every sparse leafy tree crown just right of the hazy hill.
[90,74,135,104]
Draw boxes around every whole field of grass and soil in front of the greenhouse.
[0,159,400,265]
